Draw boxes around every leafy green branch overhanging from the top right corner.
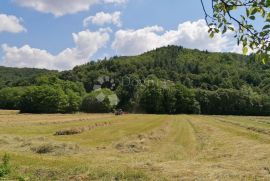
[201,0,270,63]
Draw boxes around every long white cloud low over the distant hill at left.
[2,29,110,70]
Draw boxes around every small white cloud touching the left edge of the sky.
[0,14,26,33]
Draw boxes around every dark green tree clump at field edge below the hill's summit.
[140,83,200,114]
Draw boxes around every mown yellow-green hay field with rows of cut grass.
[0,111,270,181]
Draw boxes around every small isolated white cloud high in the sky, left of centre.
[83,11,122,27]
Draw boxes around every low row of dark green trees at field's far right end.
[196,86,270,115]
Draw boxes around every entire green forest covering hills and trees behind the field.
[0,46,270,115]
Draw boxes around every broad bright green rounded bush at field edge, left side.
[20,85,82,113]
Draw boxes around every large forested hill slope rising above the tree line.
[61,46,270,93]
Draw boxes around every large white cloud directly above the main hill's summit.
[112,20,235,55]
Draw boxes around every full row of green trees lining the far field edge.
[0,76,270,115]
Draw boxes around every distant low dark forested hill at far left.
[0,66,56,88]
